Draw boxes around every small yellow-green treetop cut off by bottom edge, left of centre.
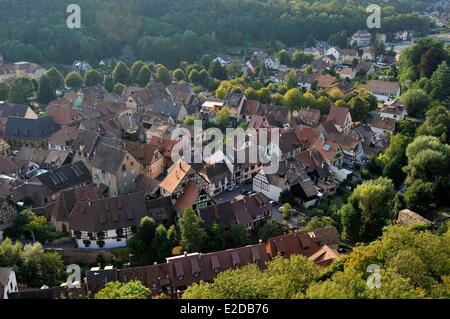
[95,280,150,299]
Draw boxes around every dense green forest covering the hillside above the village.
[0,0,433,67]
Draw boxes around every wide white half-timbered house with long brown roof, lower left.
[69,193,147,249]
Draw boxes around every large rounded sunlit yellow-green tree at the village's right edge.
[339,177,395,242]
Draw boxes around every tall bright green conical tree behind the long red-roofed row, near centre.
[179,208,207,252]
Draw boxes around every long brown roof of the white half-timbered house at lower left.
[69,192,147,232]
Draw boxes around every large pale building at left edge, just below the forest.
[0,62,47,82]
